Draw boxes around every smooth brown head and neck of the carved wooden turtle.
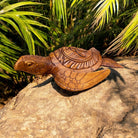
[14,55,50,75]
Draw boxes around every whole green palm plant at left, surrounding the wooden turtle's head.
[0,0,50,95]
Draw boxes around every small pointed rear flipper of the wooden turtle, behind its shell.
[102,58,123,68]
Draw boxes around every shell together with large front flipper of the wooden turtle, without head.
[49,47,110,91]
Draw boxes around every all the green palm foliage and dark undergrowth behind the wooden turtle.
[0,0,138,101]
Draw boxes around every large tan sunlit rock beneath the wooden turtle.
[0,58,138,138]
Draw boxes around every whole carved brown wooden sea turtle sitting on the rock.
[14,47,122,91]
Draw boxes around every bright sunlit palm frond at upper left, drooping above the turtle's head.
[0,2,49,55]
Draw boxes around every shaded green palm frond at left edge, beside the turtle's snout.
[0,32,21,79]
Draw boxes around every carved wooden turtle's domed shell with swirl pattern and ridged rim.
[50,47,102,71]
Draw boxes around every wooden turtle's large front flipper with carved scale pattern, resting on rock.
[54,69,110,91]
